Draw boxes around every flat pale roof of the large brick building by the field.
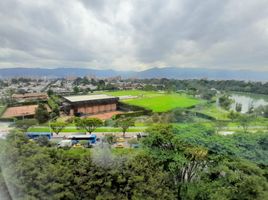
[63,94,117,103]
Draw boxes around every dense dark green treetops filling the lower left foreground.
[1,133,174,200]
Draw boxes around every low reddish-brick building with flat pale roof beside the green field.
[63,94,119,115]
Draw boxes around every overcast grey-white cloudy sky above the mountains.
[0,0,268,71]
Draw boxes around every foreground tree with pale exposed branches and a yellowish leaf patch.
[143,125,208,199]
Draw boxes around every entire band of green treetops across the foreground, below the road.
[0,125,268,200]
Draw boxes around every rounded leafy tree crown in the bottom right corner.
[185,158,268,200]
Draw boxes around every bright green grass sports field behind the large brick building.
[102,90,202,112]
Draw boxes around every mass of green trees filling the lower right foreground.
[141,126,268,199]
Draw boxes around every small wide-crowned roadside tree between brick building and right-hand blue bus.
[75,118,103,134]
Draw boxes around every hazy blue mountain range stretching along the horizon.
[0,67,268,81]
